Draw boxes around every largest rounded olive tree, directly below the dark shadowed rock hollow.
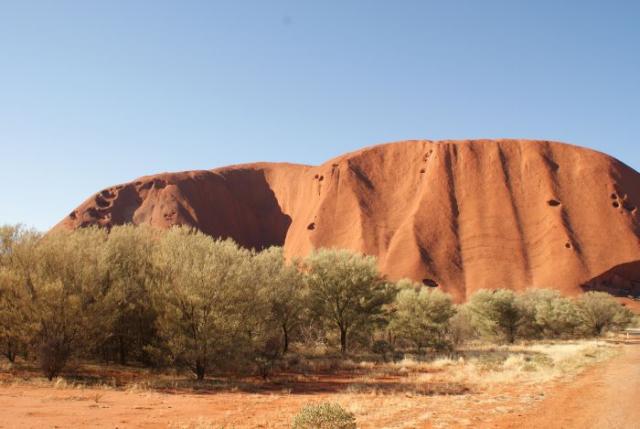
[153,227,266,380]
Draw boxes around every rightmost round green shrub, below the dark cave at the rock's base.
[576,291,634,336]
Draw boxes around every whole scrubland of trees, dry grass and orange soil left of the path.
[0,226,638,429]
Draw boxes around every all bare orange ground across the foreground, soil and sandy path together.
[0,345,640,429]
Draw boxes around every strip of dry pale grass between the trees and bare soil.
[0,340,617,396]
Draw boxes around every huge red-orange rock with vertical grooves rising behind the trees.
[55,140,640,301]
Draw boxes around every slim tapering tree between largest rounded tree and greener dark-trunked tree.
[254,247,307,353]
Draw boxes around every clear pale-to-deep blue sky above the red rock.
[0,0,640,230]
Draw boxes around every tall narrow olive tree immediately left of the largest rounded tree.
[102,225,159,365]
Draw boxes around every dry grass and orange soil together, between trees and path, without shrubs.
[0,340,620,428]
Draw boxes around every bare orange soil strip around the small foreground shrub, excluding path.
[0,374,528,429]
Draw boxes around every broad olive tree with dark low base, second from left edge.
[28,228,112,379]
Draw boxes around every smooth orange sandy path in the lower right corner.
[484,344,640,429]
